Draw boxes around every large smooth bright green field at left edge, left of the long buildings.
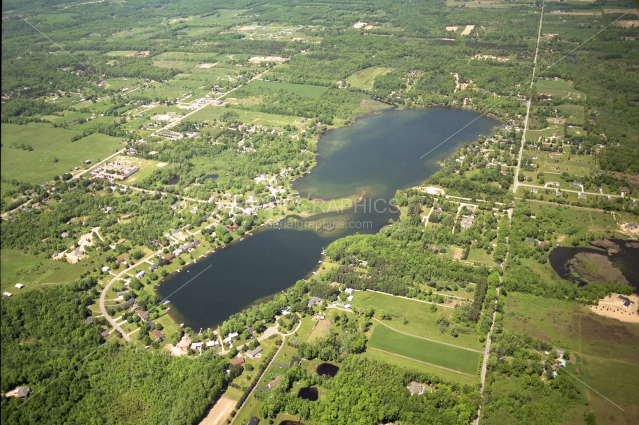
[1,124,122,184]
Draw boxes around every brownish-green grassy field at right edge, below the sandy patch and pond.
[504,293,639,425]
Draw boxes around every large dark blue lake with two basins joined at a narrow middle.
[157,108,501,329]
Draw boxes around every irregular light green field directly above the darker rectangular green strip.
[351,291,483,350]
